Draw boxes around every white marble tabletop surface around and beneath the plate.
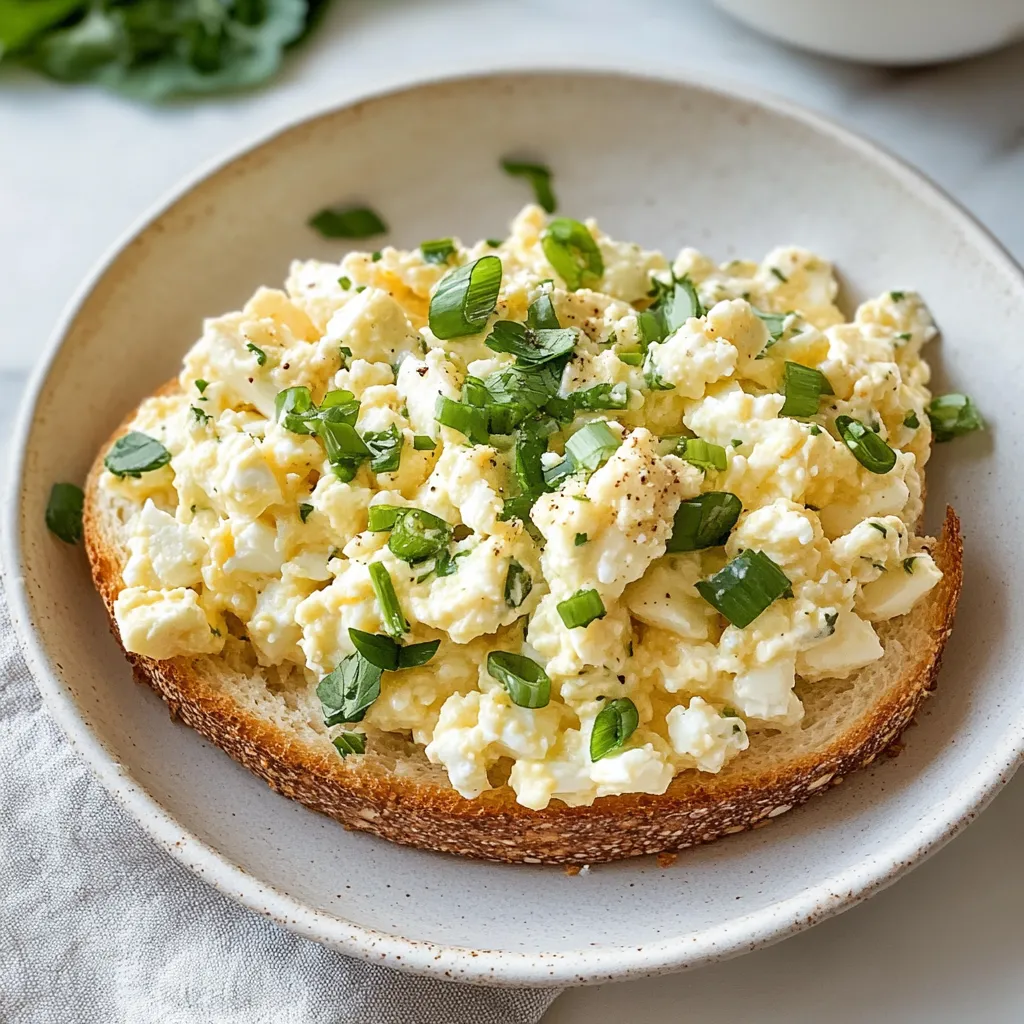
[0,0,1024,1024]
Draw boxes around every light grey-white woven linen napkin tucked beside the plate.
[0,590,558,1024]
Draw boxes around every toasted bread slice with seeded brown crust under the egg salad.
[84,384,963,864]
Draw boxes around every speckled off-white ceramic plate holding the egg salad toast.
[5,74,1024,984]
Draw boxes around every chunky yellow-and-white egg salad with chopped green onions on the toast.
[100,206,954,809]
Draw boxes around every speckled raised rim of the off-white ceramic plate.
[8,62,1024,986]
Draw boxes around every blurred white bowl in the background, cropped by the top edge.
[715,0,1024,66]
